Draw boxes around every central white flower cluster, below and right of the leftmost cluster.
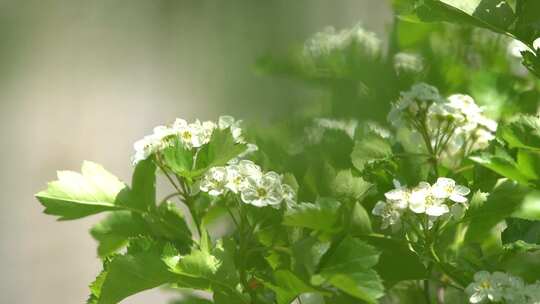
[199,160,296,207]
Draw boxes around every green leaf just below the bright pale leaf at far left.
[90,211,147,258]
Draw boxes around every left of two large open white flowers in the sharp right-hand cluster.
[409,182,450,216]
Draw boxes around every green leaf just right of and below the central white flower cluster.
[283,198,341,232]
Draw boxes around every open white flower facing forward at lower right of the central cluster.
[240,171,283,207]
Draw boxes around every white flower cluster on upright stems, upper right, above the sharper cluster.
[388,83,497,164]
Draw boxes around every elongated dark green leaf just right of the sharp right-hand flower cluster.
[464,181,527,243]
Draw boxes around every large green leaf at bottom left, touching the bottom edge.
[96,240,177,304]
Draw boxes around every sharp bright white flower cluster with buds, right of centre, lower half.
[372,177,470,230]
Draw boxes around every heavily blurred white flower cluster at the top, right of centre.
[304,25,381,57]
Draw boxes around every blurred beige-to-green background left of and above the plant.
[0,0,391,304]
